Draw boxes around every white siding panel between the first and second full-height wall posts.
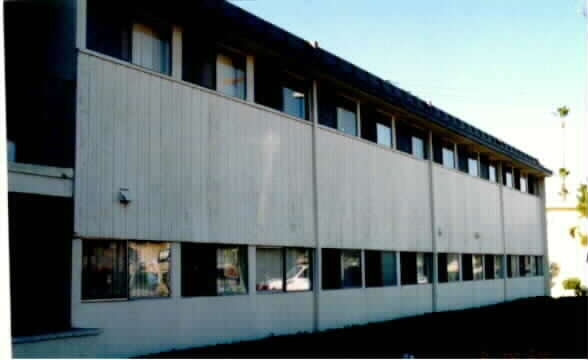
[317,128,432,251]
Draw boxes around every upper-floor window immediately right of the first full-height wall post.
[318,89,358,136]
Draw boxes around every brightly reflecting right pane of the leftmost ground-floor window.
[129,241,170,298]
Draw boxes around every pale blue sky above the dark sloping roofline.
[232,0,588,202]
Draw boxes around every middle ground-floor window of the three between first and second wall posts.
[365,251,398,287]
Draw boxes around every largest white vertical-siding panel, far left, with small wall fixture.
[75,54,314,246]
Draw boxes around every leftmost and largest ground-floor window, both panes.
[82,240,171,300]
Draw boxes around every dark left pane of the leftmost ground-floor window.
[82,240,127,300]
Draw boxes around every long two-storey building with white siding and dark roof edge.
[4,0,551,357]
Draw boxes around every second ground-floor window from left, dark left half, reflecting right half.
[182,243,247,296]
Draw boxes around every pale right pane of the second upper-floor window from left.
[217,52,247,100]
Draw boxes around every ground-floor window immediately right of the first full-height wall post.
[321,249,362,290]
